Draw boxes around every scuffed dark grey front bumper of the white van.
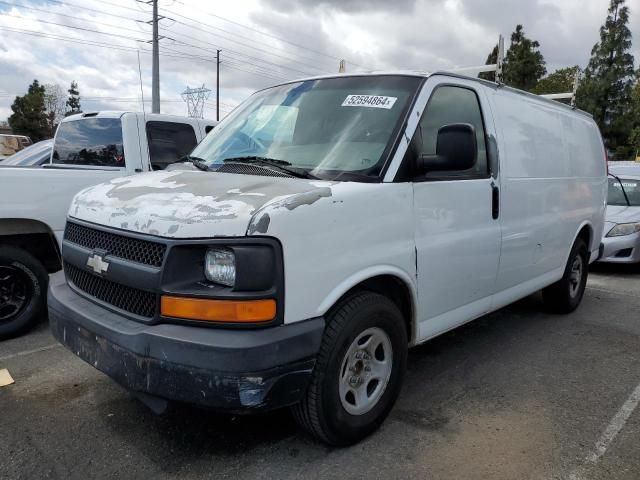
[48,272,324,411]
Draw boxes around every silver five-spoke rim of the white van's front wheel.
[338,327,393,415]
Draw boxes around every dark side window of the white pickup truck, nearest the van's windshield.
[147,122,198,170]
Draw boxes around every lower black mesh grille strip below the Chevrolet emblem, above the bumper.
[64,263,156,318]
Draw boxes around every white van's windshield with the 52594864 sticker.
[192,75,421,180]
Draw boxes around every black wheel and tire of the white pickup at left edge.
[0,246,49,340]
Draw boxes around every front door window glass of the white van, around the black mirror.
[409,86,489,180]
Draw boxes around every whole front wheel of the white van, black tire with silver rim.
[292,292,408,446]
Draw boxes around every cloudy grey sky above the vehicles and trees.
[0,0,640,121]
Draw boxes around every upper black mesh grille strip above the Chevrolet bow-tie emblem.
[64,222,167,267]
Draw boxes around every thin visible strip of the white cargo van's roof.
[261,70,593,118]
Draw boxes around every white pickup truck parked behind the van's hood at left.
[0,111,216,339]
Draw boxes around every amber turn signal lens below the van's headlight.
[160,295,276,323]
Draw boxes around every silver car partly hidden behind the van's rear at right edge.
[600,162,640,263]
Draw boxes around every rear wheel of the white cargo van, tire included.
[542,238,589,313]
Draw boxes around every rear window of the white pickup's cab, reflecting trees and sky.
[52,118,124,167]
